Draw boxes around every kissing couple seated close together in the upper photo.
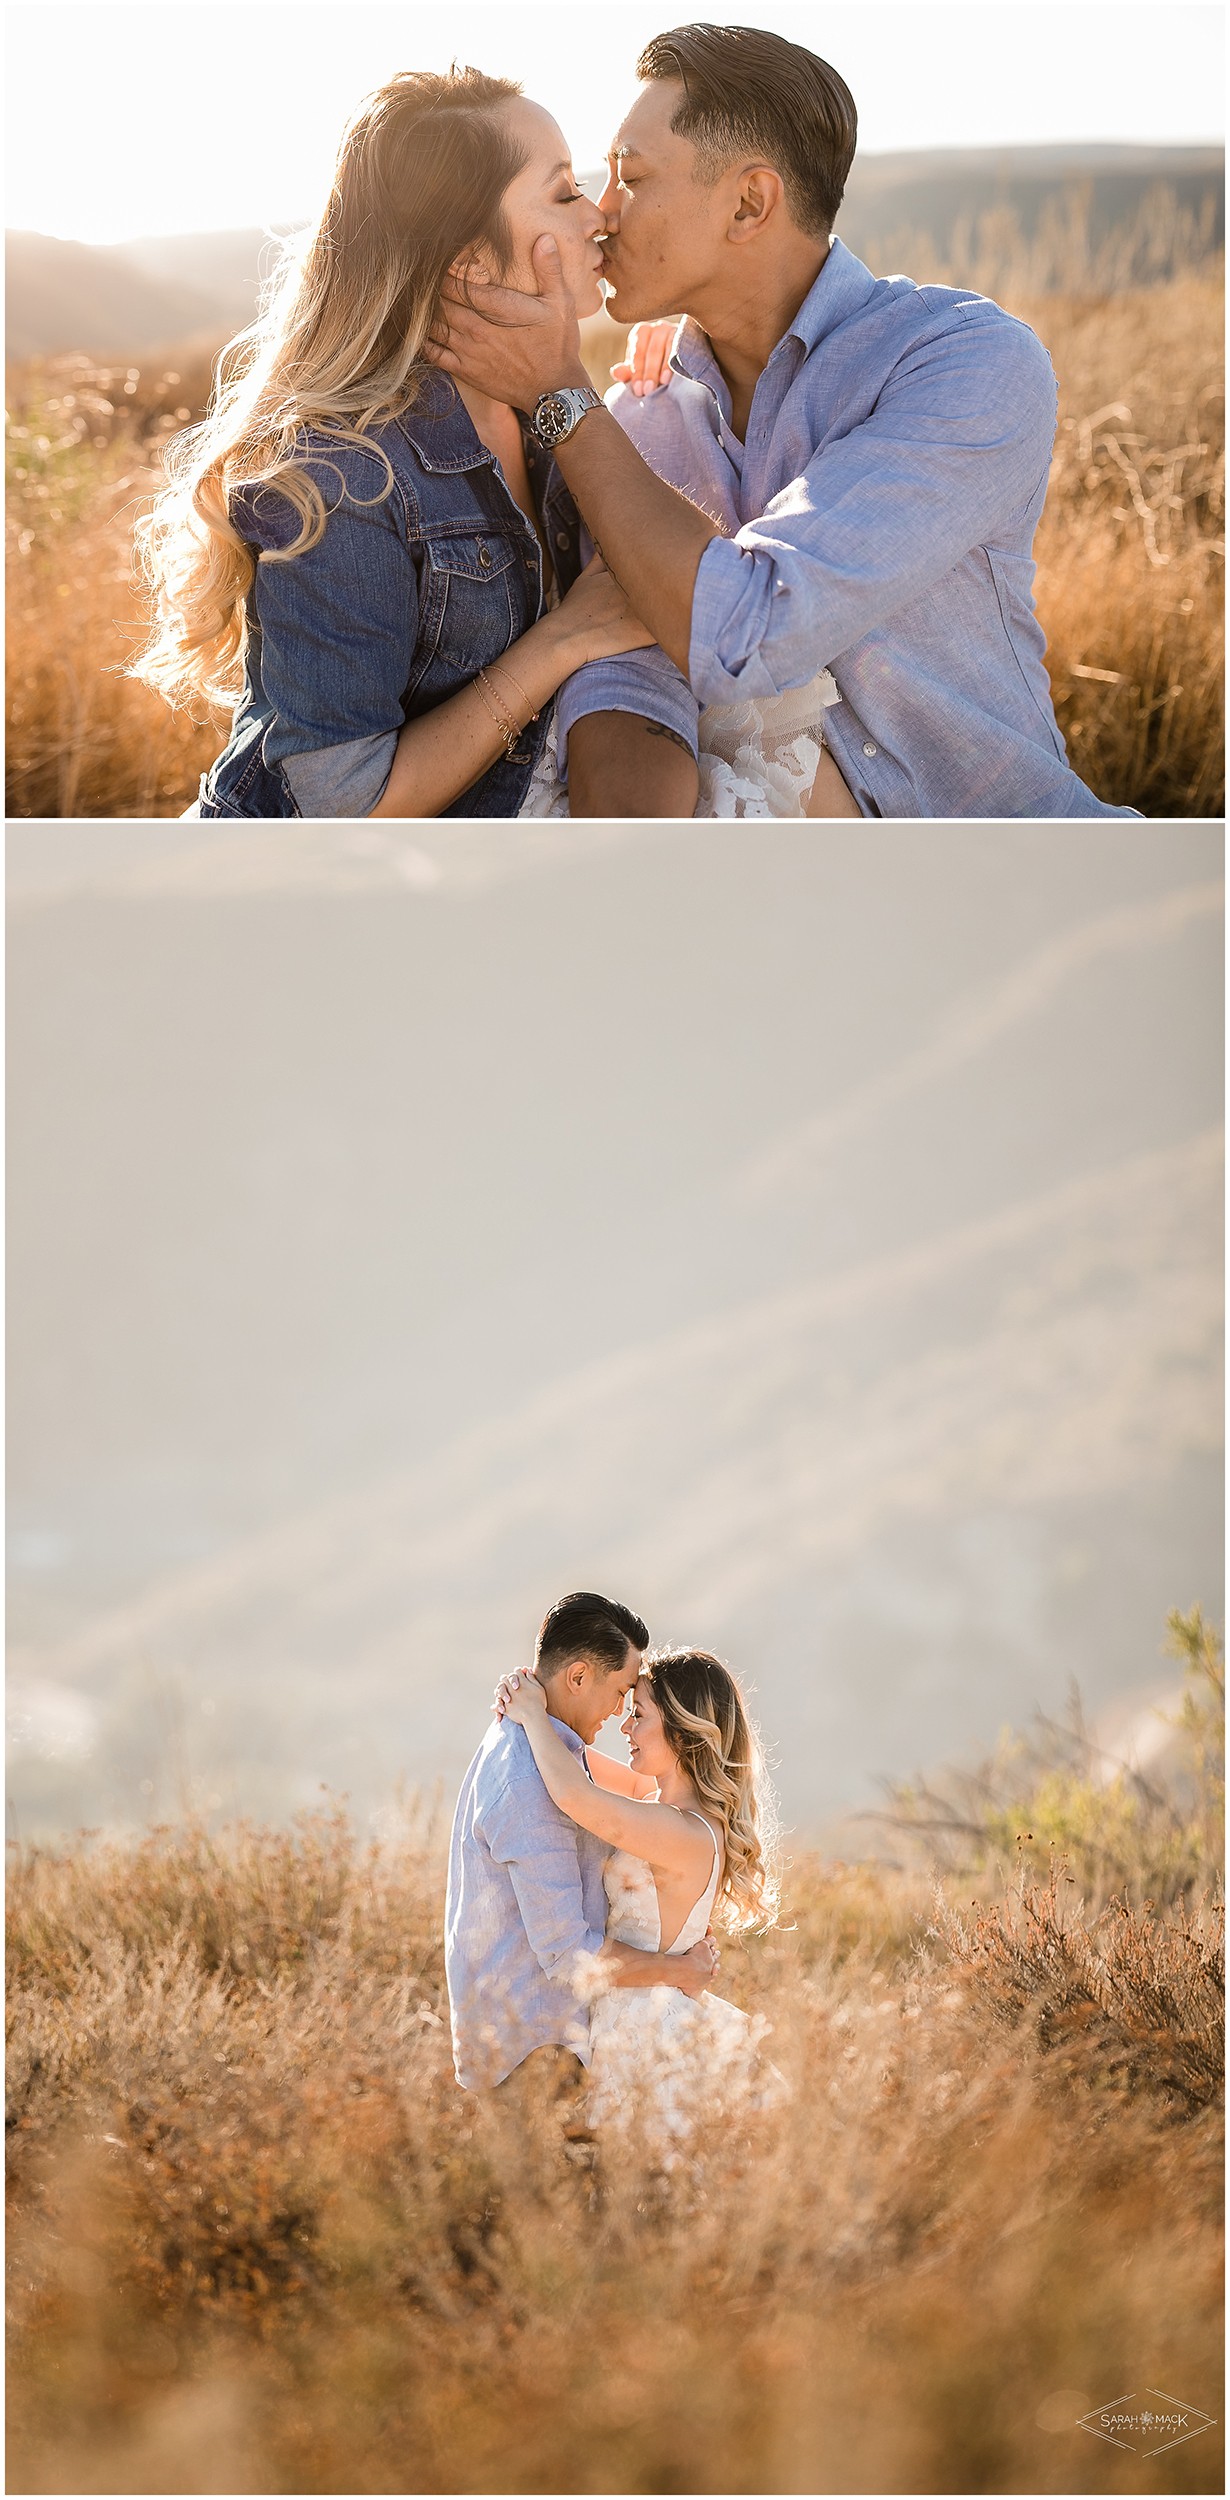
[135,25,1135,818]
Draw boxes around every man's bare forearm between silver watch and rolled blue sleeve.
[555,408,723,675]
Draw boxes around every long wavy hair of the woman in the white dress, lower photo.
[643,1650,780,1928]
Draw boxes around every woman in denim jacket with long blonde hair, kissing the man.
[133,68,653,818]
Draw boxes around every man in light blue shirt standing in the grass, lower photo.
[445,1590,718,2093]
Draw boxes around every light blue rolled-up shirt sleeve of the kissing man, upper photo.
[688,300,1058,705]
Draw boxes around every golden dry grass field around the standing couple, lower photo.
[8,1615,1225,2493]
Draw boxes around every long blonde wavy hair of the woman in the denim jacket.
[128,65,528,713]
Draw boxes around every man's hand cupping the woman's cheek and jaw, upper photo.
[423,235,590,408]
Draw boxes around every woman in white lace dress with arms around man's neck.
[498,1650,780,2170]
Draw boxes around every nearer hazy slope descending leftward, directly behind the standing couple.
[15,1135,1220,1820]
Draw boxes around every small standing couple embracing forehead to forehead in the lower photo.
[445,1590,780,2170]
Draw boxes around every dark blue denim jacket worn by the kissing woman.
[200,373,580,818]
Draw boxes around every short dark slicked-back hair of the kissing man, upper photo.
[638,25,858,235]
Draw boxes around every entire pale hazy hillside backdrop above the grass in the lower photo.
[10,828,1220,1828]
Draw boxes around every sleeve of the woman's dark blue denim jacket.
[235,445,418,815]
